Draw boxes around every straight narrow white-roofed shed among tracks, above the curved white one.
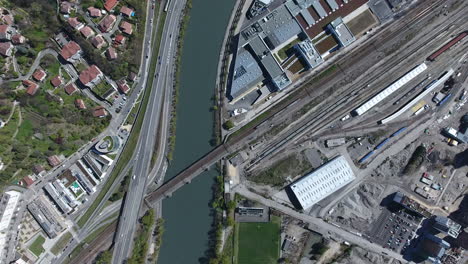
[353,63,427,115]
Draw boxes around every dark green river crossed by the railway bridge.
[158,0,235,264]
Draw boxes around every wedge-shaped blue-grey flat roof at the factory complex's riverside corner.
[230,48,263,98]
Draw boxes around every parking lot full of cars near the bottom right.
[368,208,421,253]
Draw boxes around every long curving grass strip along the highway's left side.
[77,3,166,227]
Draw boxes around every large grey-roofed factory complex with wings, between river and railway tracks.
[227,0,368,103]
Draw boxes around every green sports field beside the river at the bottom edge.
[236,216,281,264]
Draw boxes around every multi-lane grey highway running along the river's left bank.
[112,1,185,264]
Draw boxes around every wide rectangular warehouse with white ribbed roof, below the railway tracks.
[288,156,356,210]
